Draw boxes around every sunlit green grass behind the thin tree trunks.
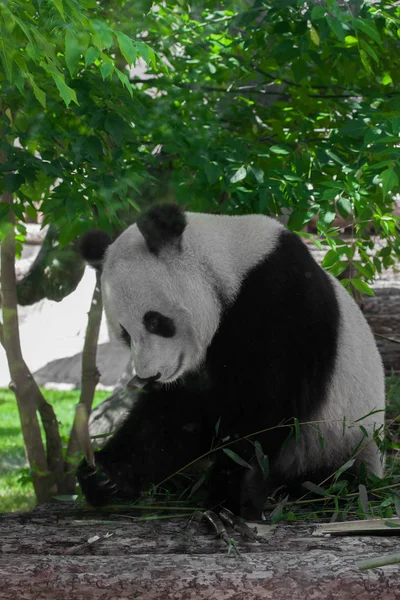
[0,389,110,512]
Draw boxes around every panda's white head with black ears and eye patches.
[81,204,221,383]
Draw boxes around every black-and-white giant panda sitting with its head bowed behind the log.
[78,204,385,519]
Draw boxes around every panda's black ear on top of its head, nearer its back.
[136,204,186,254]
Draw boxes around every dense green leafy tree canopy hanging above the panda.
[0,0,400,290]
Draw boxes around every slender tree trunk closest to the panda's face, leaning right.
[66,272,103,493]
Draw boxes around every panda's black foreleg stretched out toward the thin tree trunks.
[77,385,212,506]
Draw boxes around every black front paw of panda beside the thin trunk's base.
[76,459,118,506]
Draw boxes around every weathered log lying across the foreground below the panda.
[0,506,400,600]
